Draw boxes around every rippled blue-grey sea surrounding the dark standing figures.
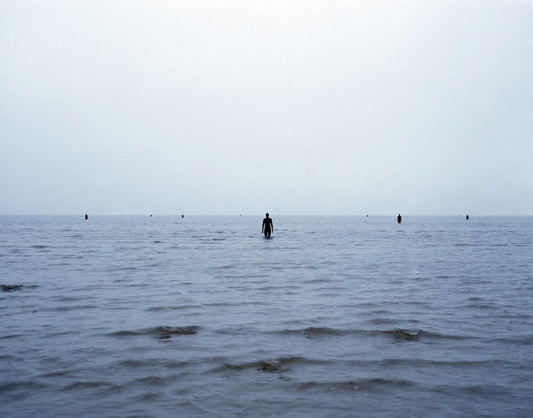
[0,214,533,417]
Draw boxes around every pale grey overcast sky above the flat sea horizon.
[0,0,533,215]
